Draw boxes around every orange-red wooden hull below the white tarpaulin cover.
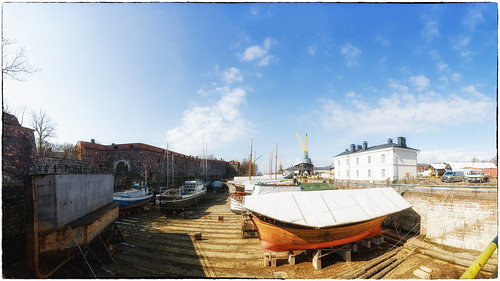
[250,215,385,252]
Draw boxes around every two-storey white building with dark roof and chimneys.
[333,137,420,182]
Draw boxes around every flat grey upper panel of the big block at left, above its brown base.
[35,175,113,230]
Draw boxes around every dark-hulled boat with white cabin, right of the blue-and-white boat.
[160,180,207,214]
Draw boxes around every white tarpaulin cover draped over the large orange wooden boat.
[243,188,411,228]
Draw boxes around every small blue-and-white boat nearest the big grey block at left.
[113,184,153,213]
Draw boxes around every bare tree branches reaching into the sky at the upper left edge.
[2,38,39,81]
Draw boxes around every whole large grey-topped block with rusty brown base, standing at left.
[24,174,119,278]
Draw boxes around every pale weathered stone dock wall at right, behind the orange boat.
[403,188,498,251]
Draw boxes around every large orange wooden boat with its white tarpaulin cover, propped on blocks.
[243,188,411,252]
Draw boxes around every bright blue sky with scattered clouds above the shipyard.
[2,3,498,172]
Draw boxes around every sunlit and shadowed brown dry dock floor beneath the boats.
[4,190,493,279]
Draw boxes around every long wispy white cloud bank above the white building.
[318,80,496,135]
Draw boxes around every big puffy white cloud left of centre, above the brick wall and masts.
[166,86,250,155]
